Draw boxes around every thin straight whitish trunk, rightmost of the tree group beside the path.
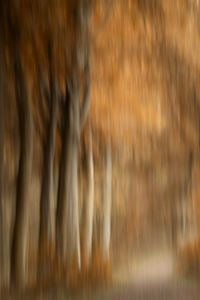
[103,143,112,262]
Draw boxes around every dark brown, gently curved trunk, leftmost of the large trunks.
[11,54,33,288]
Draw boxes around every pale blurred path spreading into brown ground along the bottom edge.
[2,250,200,300]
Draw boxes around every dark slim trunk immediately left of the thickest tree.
[39,43,58,276]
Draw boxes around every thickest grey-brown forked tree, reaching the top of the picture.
[56,0,90,269]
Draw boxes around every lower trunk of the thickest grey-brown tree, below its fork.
[57,79,80,268]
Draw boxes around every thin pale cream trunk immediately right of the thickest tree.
[82,129,94,269]
